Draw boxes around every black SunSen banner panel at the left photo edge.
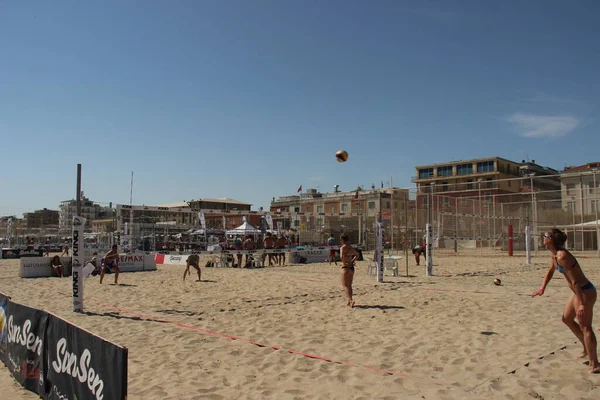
[3,301,48,397]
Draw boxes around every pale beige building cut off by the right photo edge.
[560,162,600,217]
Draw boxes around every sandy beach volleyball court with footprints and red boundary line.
[0,252,600,399]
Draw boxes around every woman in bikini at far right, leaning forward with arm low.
[532,228,600,373]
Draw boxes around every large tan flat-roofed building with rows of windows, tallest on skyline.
[412,157,559,208]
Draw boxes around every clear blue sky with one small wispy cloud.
[0,0,600,215]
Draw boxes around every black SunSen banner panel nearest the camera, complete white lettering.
[46,314,127,400]
